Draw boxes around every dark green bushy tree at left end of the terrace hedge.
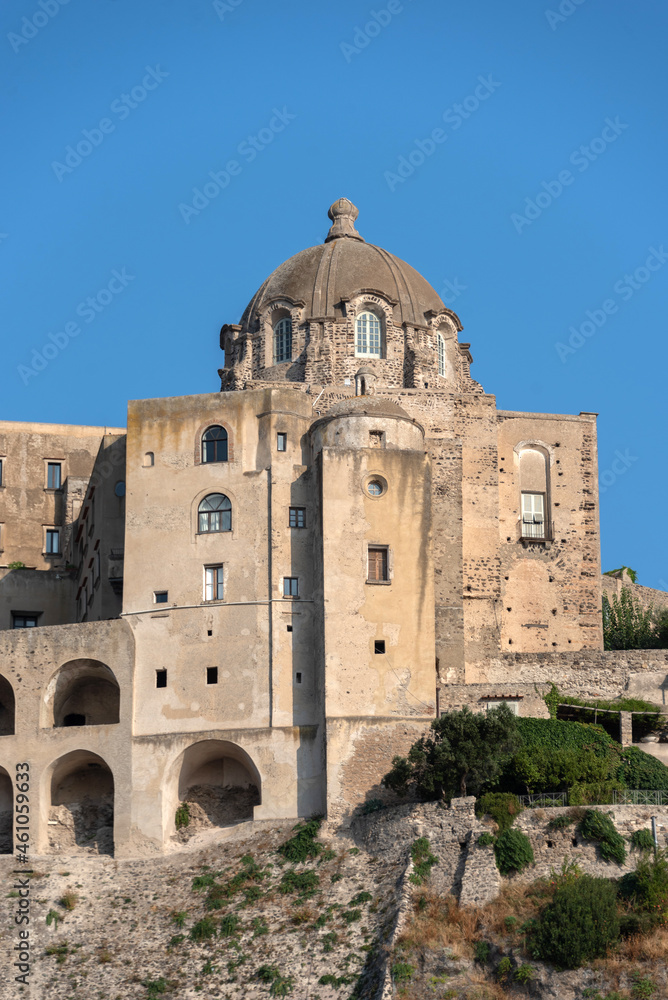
[383,705,520,799]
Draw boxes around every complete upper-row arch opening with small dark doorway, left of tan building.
[42,659,121,728]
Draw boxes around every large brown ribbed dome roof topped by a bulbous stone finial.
[241,198,445,328]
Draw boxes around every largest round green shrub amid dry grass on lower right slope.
[532,875,619,969]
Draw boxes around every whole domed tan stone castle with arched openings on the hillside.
[0,198,666,856]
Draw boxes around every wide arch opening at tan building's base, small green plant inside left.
[168,740,261,837]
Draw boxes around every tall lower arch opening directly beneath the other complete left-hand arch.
[49,750,114,854]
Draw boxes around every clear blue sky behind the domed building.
[0,0,668,589]
